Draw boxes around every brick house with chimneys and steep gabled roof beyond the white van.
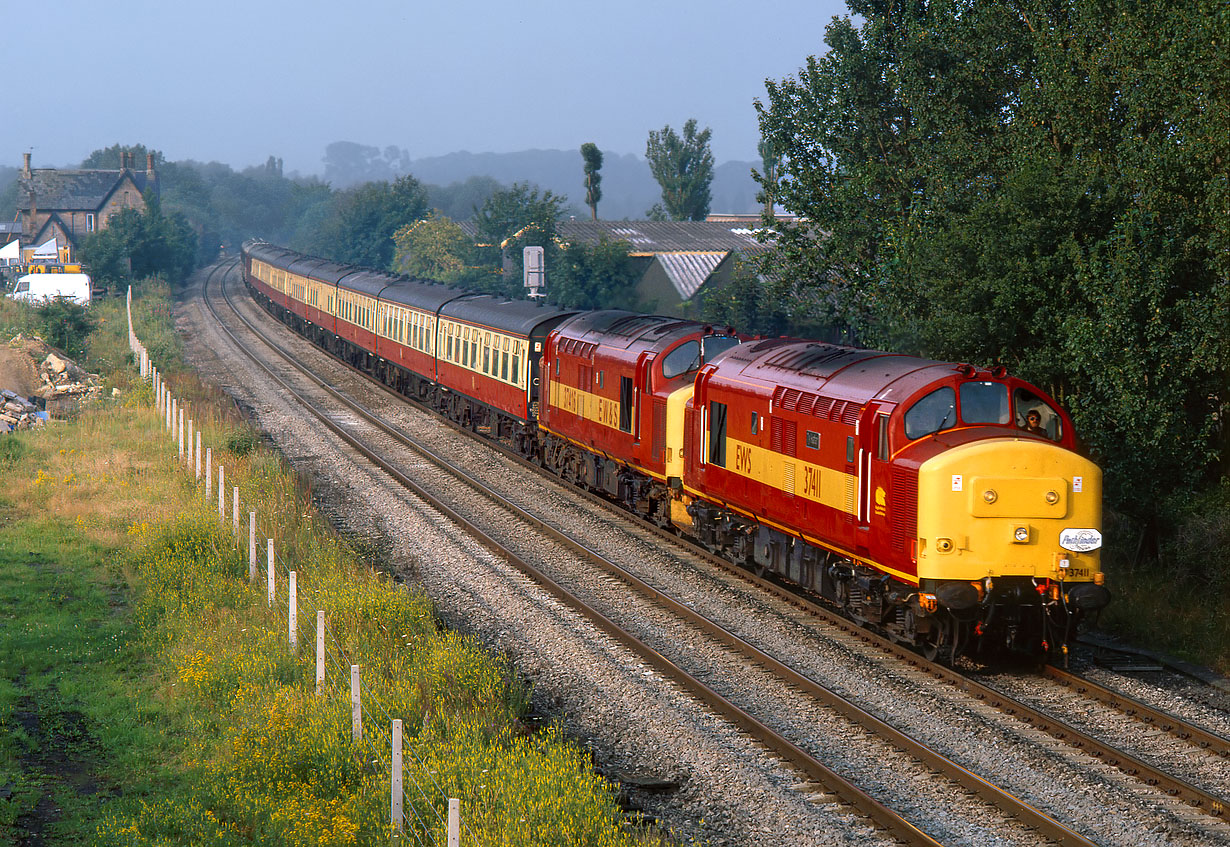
[17,152,159,263]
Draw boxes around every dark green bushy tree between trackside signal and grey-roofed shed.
[547,236,638,310]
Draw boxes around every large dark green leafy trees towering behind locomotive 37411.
[756,0,1230,518]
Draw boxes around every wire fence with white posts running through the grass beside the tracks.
[127,286,467,847]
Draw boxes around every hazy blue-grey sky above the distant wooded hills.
[7,0,846,173]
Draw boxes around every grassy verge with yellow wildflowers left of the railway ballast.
[0,285,659,846]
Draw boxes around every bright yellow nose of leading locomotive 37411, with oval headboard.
[918,438,1102,583]
